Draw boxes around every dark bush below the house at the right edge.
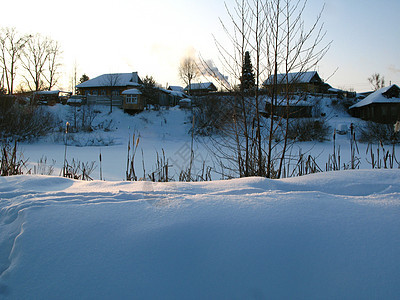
[357,122,400,143]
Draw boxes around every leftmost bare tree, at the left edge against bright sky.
[0,28,30,94]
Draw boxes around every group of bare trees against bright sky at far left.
[0,27,62,95]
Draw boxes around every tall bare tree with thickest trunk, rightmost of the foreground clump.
[266,0,331,178]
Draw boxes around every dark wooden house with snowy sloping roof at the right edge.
[349,84,400,124]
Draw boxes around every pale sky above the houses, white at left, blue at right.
[0,0,400,91]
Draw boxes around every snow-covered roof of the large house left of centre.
[76,72,142,88]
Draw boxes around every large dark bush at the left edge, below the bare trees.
[0,96,56,140]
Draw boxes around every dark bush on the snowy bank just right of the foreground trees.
[288,119,330,142]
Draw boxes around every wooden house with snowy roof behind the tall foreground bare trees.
[263,71,331,94]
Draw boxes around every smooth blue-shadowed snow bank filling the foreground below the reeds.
[0,170,400,299]
